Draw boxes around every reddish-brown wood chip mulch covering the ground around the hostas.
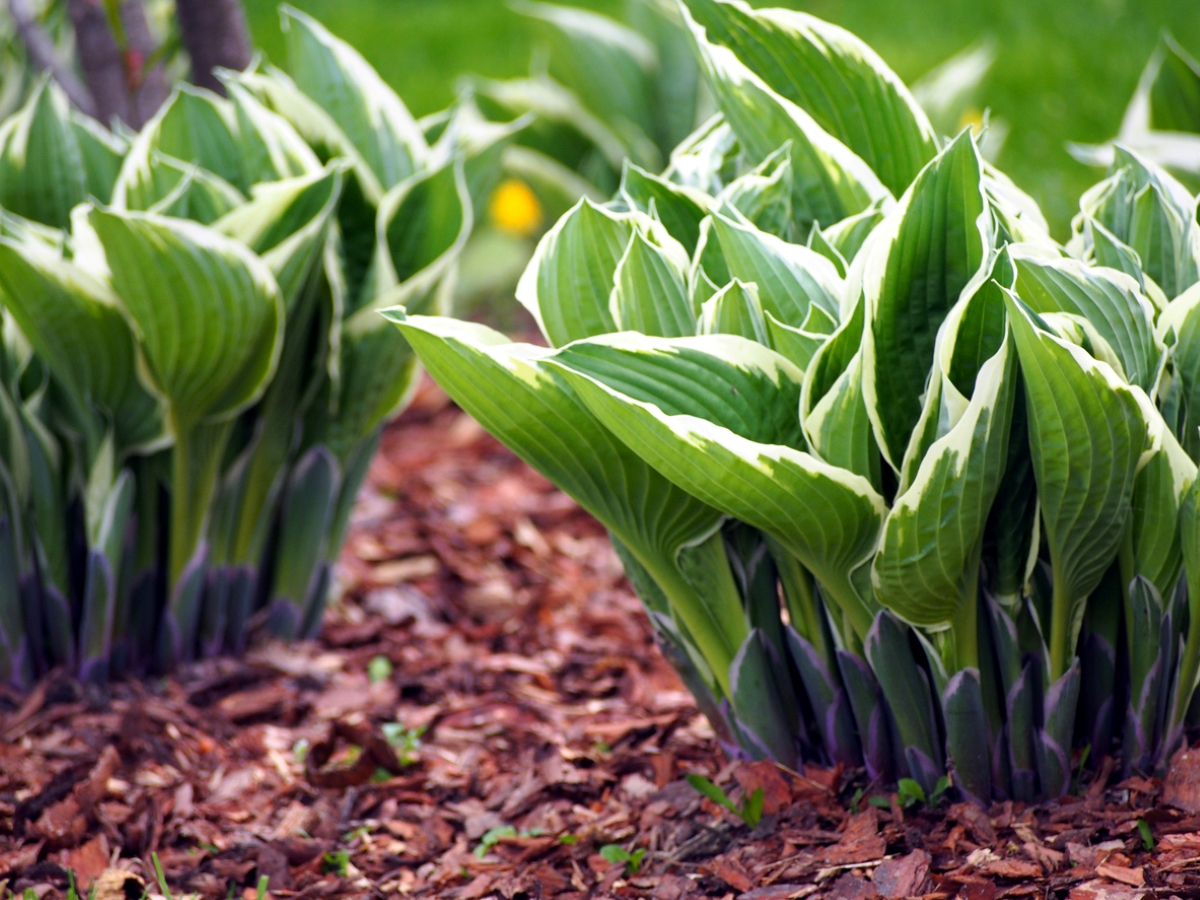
[0,384,1200,900]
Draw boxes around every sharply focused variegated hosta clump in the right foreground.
[389,0,1200,802]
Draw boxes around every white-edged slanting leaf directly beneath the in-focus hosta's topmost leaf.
[688,6,890,228]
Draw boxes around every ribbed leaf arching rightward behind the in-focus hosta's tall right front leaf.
[1009,245,1163,391]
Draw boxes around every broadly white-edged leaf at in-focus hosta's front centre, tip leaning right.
[871,340,1016,626]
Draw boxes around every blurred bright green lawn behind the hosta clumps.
[246,0,1200,239]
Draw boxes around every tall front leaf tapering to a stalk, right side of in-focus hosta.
[1008,294,1147,680]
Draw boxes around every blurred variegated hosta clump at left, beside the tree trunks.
[0,8,523,684]
